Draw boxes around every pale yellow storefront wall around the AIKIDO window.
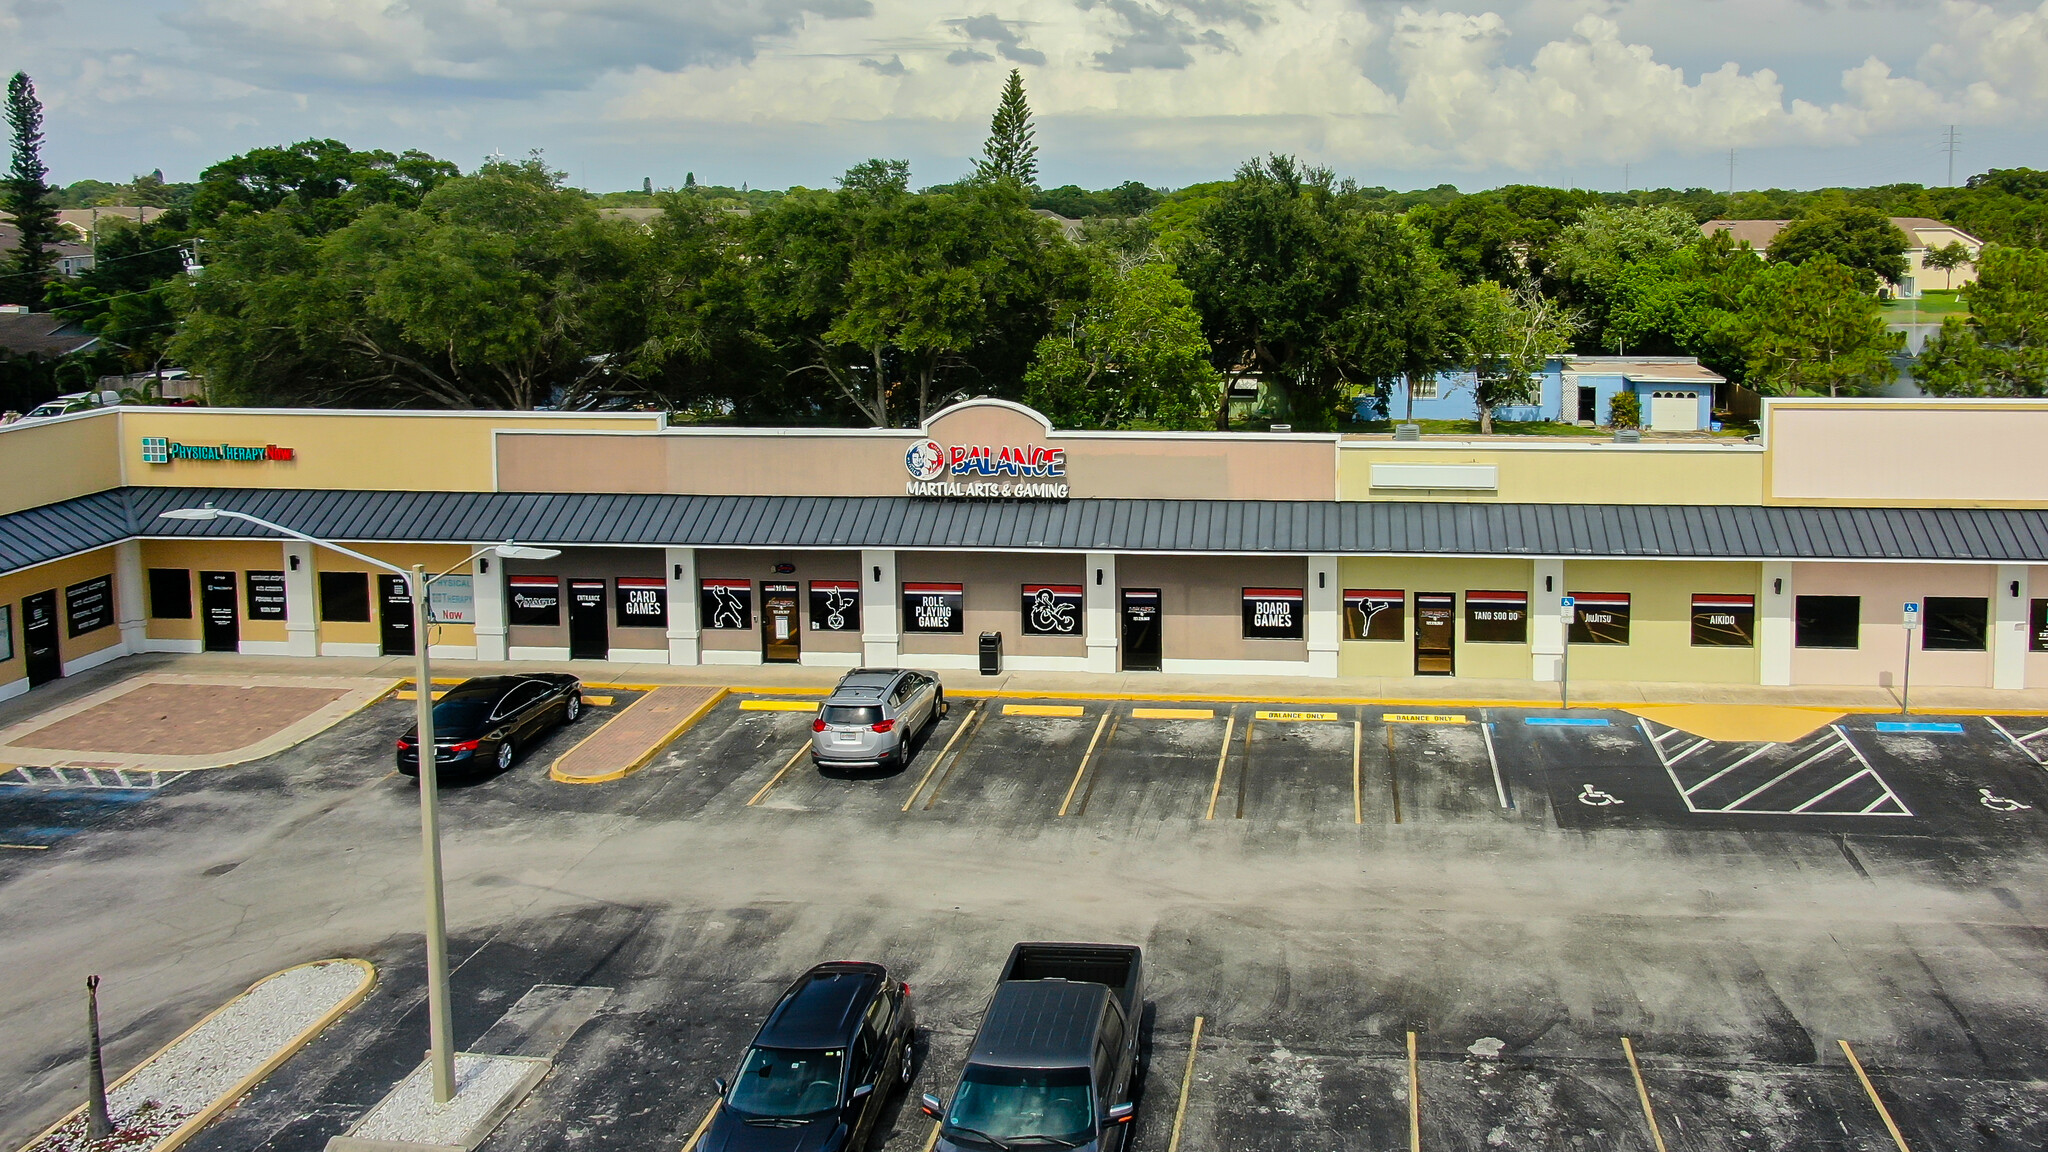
[1565,560,1763,685]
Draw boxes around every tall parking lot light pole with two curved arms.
[158,504,561,1105]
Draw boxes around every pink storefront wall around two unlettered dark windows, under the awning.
[1792,564,1998,687]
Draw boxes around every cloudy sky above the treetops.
[0,0,2048,189]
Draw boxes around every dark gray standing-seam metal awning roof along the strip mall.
[0,488,2048,572]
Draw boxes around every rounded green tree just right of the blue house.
[1741,256,1903,396]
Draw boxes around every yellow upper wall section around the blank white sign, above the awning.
[1337,441,1763,504]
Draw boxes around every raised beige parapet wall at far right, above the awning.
[1763,400,2048,508]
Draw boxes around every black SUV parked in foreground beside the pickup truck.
[696,961,918,1152]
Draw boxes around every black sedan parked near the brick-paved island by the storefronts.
[397,672,584,777]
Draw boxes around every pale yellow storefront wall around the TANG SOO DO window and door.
[1337,556,1536,681]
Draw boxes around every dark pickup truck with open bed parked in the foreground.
[922,943,1145,1152]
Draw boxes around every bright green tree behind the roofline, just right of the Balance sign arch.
[1024,260,1221,428]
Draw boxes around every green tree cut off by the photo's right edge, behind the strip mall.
[1915,248,2048,396]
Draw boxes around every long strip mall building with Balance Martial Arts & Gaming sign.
[0,400,2048,695]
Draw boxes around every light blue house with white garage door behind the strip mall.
[1358,357,1726,433]
